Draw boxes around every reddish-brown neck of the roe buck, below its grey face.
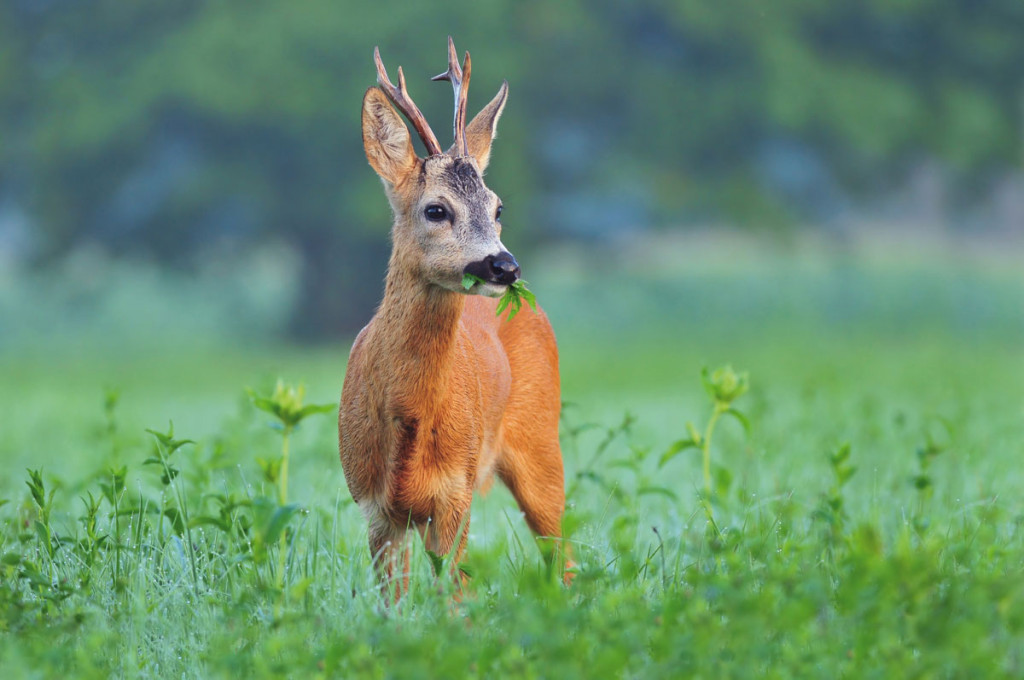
[378,246,465,411]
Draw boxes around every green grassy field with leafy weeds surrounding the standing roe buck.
[0,241,1024,678]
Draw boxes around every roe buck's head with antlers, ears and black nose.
[362,37,519,297]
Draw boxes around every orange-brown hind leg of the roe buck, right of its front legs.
[498,439,572,585]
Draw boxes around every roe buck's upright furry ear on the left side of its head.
[362,87,417,185]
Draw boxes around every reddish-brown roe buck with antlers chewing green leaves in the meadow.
[338,38,571,597]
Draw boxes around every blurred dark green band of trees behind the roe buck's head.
[0,0,1024,337]
